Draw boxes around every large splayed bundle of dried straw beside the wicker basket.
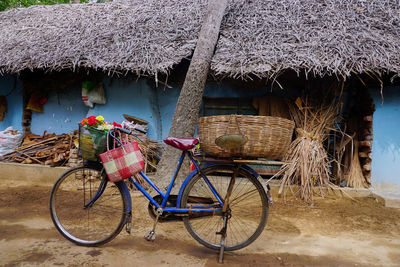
[275,100,337,202]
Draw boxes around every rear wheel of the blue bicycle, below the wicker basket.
[180,165,268,251]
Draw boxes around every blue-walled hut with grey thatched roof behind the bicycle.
[0,0,400,192]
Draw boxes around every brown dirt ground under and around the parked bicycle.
[0,183,400,267]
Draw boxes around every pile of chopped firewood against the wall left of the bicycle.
[2,132,76,166]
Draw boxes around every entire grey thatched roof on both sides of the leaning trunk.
[0,0,400,78]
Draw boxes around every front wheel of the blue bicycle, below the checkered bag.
[50,167,126,246]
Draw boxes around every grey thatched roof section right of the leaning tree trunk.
[212,0,400,77]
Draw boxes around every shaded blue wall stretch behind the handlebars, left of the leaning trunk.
[31,78,180,140]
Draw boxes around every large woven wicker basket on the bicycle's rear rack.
[198,115,294,159]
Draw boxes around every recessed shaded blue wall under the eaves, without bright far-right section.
[0,76,296,140]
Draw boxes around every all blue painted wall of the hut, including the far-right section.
[0,72,400,187]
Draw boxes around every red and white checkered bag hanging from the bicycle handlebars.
[99,133,144,182]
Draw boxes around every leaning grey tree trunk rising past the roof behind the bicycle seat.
[157,0,228,187]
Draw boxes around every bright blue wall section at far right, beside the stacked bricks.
[370,86,400,188]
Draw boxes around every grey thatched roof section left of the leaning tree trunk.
[0,0,207,73]
